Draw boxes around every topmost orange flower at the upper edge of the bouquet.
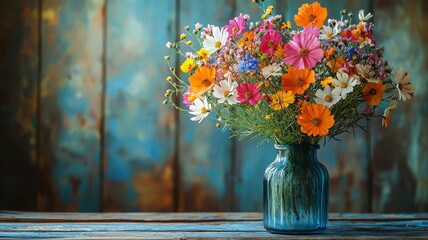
[294,2,327,28]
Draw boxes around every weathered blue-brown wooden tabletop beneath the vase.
[0,211,428,239]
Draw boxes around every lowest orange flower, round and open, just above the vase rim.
[297,103,334,137]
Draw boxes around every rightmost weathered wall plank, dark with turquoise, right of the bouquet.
[371,0,428,212]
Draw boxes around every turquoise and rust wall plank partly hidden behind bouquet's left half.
[178,0,234,211]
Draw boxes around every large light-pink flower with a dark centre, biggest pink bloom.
[284,34,324,69]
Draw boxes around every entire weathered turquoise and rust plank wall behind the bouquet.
[0,0,428,212]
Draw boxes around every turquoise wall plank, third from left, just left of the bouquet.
[103,0,177,211]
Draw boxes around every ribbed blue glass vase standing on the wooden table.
[263,144,329,234]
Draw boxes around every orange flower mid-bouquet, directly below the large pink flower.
[281,66,315,94]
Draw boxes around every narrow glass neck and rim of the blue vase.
[274,144,319,163]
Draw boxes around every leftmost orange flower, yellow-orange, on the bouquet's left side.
[189,66,216,97]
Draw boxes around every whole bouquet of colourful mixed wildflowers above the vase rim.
[165,1,415,144]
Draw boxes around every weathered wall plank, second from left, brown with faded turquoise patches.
[37,0,104,211]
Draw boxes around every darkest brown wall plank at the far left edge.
[0,0,38,210]
